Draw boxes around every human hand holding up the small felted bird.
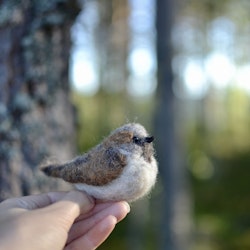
[0,191,129,250]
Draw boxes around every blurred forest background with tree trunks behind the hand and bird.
[0,0,250,250]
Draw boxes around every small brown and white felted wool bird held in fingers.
[41,123,158,202]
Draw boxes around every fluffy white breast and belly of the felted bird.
[76,151,158,201]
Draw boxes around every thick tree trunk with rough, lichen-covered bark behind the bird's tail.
[0,0,79,200]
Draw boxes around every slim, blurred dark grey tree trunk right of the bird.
[155,0,190,250]
